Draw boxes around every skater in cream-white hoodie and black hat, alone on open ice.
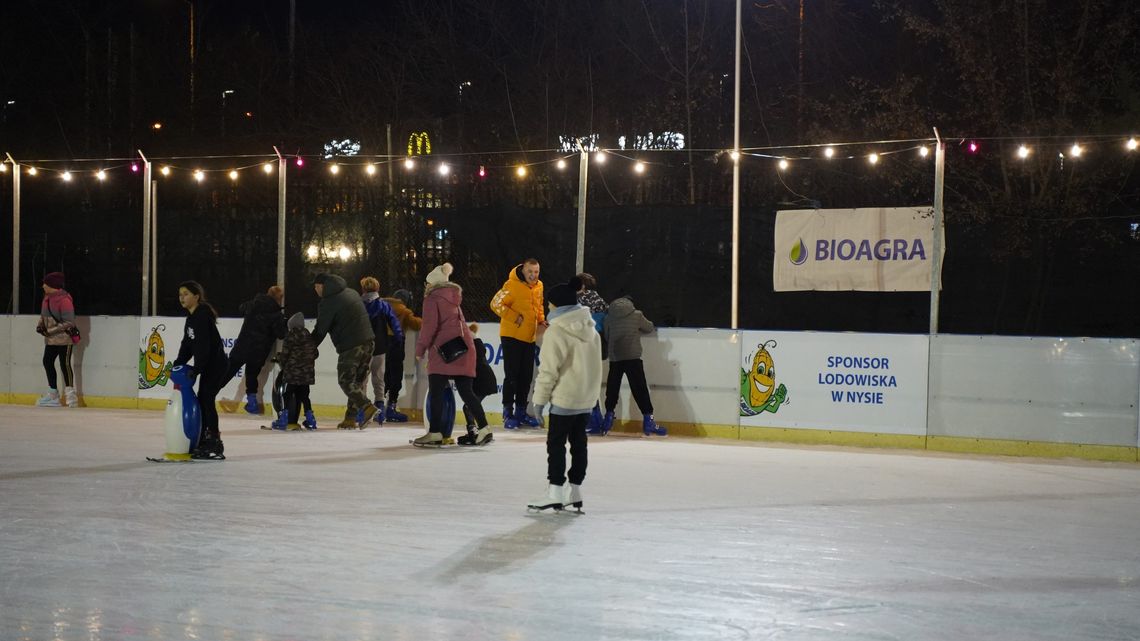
[528,277,602,511]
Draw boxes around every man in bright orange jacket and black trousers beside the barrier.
[491,258,546,430]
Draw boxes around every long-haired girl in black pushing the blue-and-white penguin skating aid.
[173,281,228,459]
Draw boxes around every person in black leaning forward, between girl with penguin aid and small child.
[222,285,288,414]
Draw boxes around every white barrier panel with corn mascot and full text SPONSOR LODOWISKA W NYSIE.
[739,331,928,436]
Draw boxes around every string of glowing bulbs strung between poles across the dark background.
[0,135,1140,182]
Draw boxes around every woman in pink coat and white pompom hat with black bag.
[414,262,491,445]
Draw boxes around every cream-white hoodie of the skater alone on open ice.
[531,305,602,414]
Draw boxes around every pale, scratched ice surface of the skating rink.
[0,405,1140,641]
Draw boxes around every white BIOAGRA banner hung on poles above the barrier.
[772,206,946,292]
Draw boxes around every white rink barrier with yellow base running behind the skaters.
[0,315,1140,461]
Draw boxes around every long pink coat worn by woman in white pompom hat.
[416,283,475,376]
